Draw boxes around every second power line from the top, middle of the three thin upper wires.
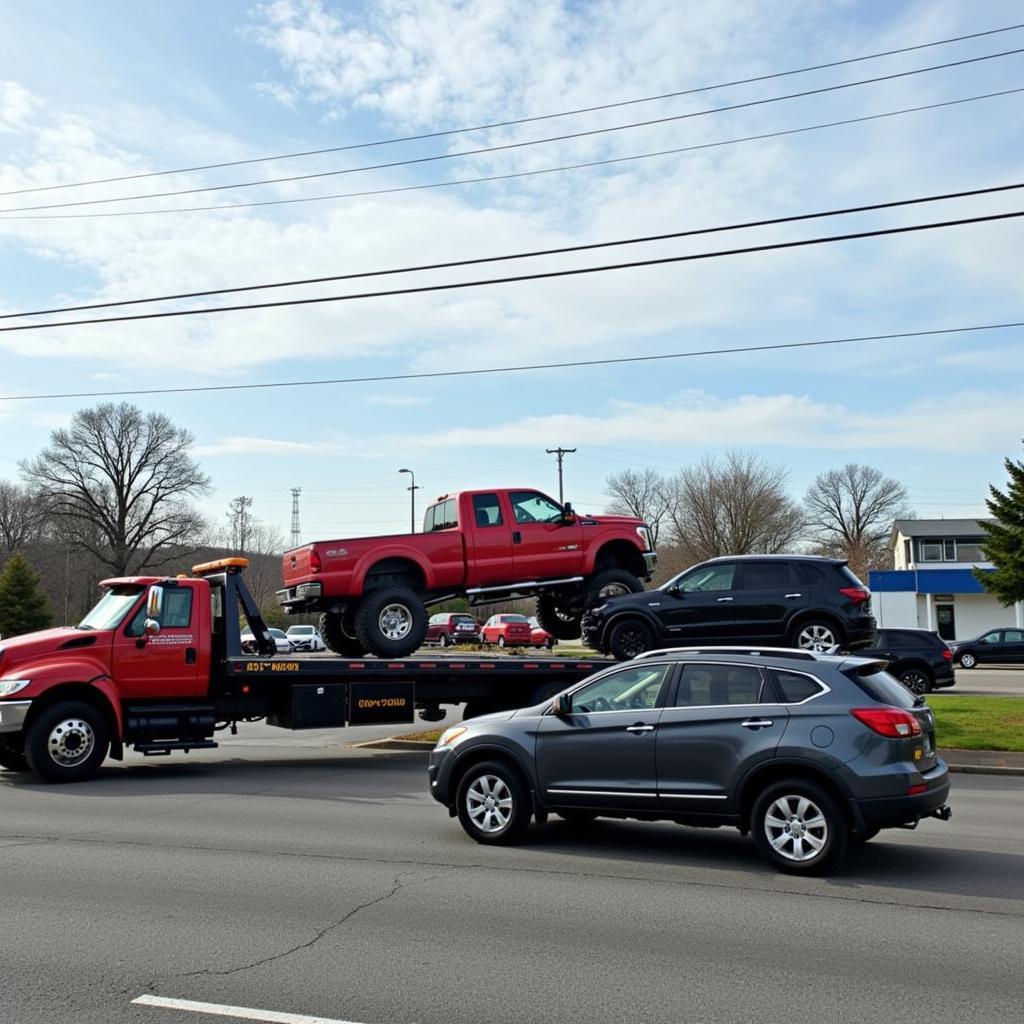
[0,47,1024,214]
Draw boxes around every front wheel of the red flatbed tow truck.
[25,700,111,782]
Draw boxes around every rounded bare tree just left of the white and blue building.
[804,462,913,575]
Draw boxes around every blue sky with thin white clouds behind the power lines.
[0,0,1024,539]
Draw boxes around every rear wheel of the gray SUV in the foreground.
[751,778,850,874]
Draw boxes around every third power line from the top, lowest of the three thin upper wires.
[0,88,1024,221]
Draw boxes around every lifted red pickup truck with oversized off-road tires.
[278,488,656,657]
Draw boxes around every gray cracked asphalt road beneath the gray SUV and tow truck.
[0,727,1024,1024]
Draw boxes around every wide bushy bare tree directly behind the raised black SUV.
[664,452,803,562]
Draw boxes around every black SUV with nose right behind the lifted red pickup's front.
[583,555,874,660]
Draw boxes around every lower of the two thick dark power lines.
[0,210,1024,333]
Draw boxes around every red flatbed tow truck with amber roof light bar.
[0,558,606,782]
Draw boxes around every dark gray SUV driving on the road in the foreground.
[429,647,949,874]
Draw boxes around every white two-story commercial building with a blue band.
[868,519,1024,640]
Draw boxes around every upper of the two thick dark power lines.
[0,178,1024,321]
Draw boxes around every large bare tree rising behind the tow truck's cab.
[22,402,210,575]
